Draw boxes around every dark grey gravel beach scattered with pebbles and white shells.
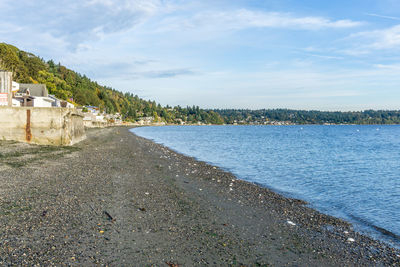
[0,127,400,266]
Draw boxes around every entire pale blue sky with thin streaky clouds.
[0,0,400,111]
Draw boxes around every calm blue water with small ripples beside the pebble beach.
[132,125,400,247]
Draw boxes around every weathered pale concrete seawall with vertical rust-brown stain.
[0,107,86,145]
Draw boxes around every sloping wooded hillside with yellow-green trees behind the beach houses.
[0,43,224,124]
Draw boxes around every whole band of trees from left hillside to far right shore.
[0,43,400,124]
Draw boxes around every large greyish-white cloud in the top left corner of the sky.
[0,0,170,50]
